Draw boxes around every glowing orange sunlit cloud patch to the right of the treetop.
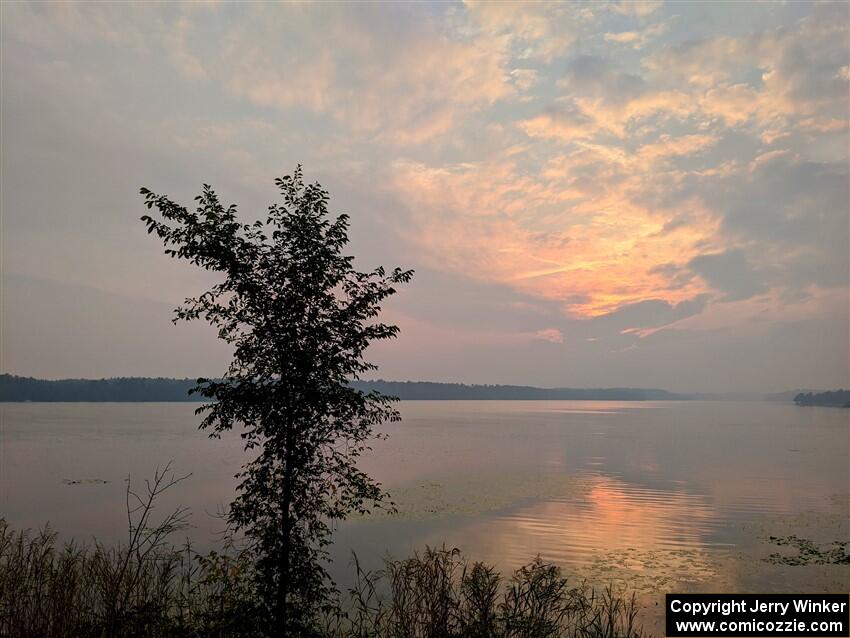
[394,156,716,316]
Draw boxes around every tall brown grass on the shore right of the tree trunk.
[332,548,643,638]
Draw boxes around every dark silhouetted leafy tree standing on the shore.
[141,165,413,635]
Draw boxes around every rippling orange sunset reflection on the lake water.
[334,474,730,571]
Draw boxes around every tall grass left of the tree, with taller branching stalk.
[0,467,256,638]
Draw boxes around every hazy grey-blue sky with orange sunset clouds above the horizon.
[0,1,850,392]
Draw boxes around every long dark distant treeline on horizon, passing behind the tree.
[0,374,691,402]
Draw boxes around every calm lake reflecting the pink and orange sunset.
[0,401,850,634]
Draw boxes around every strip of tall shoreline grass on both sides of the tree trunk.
[0,521,641,638]
